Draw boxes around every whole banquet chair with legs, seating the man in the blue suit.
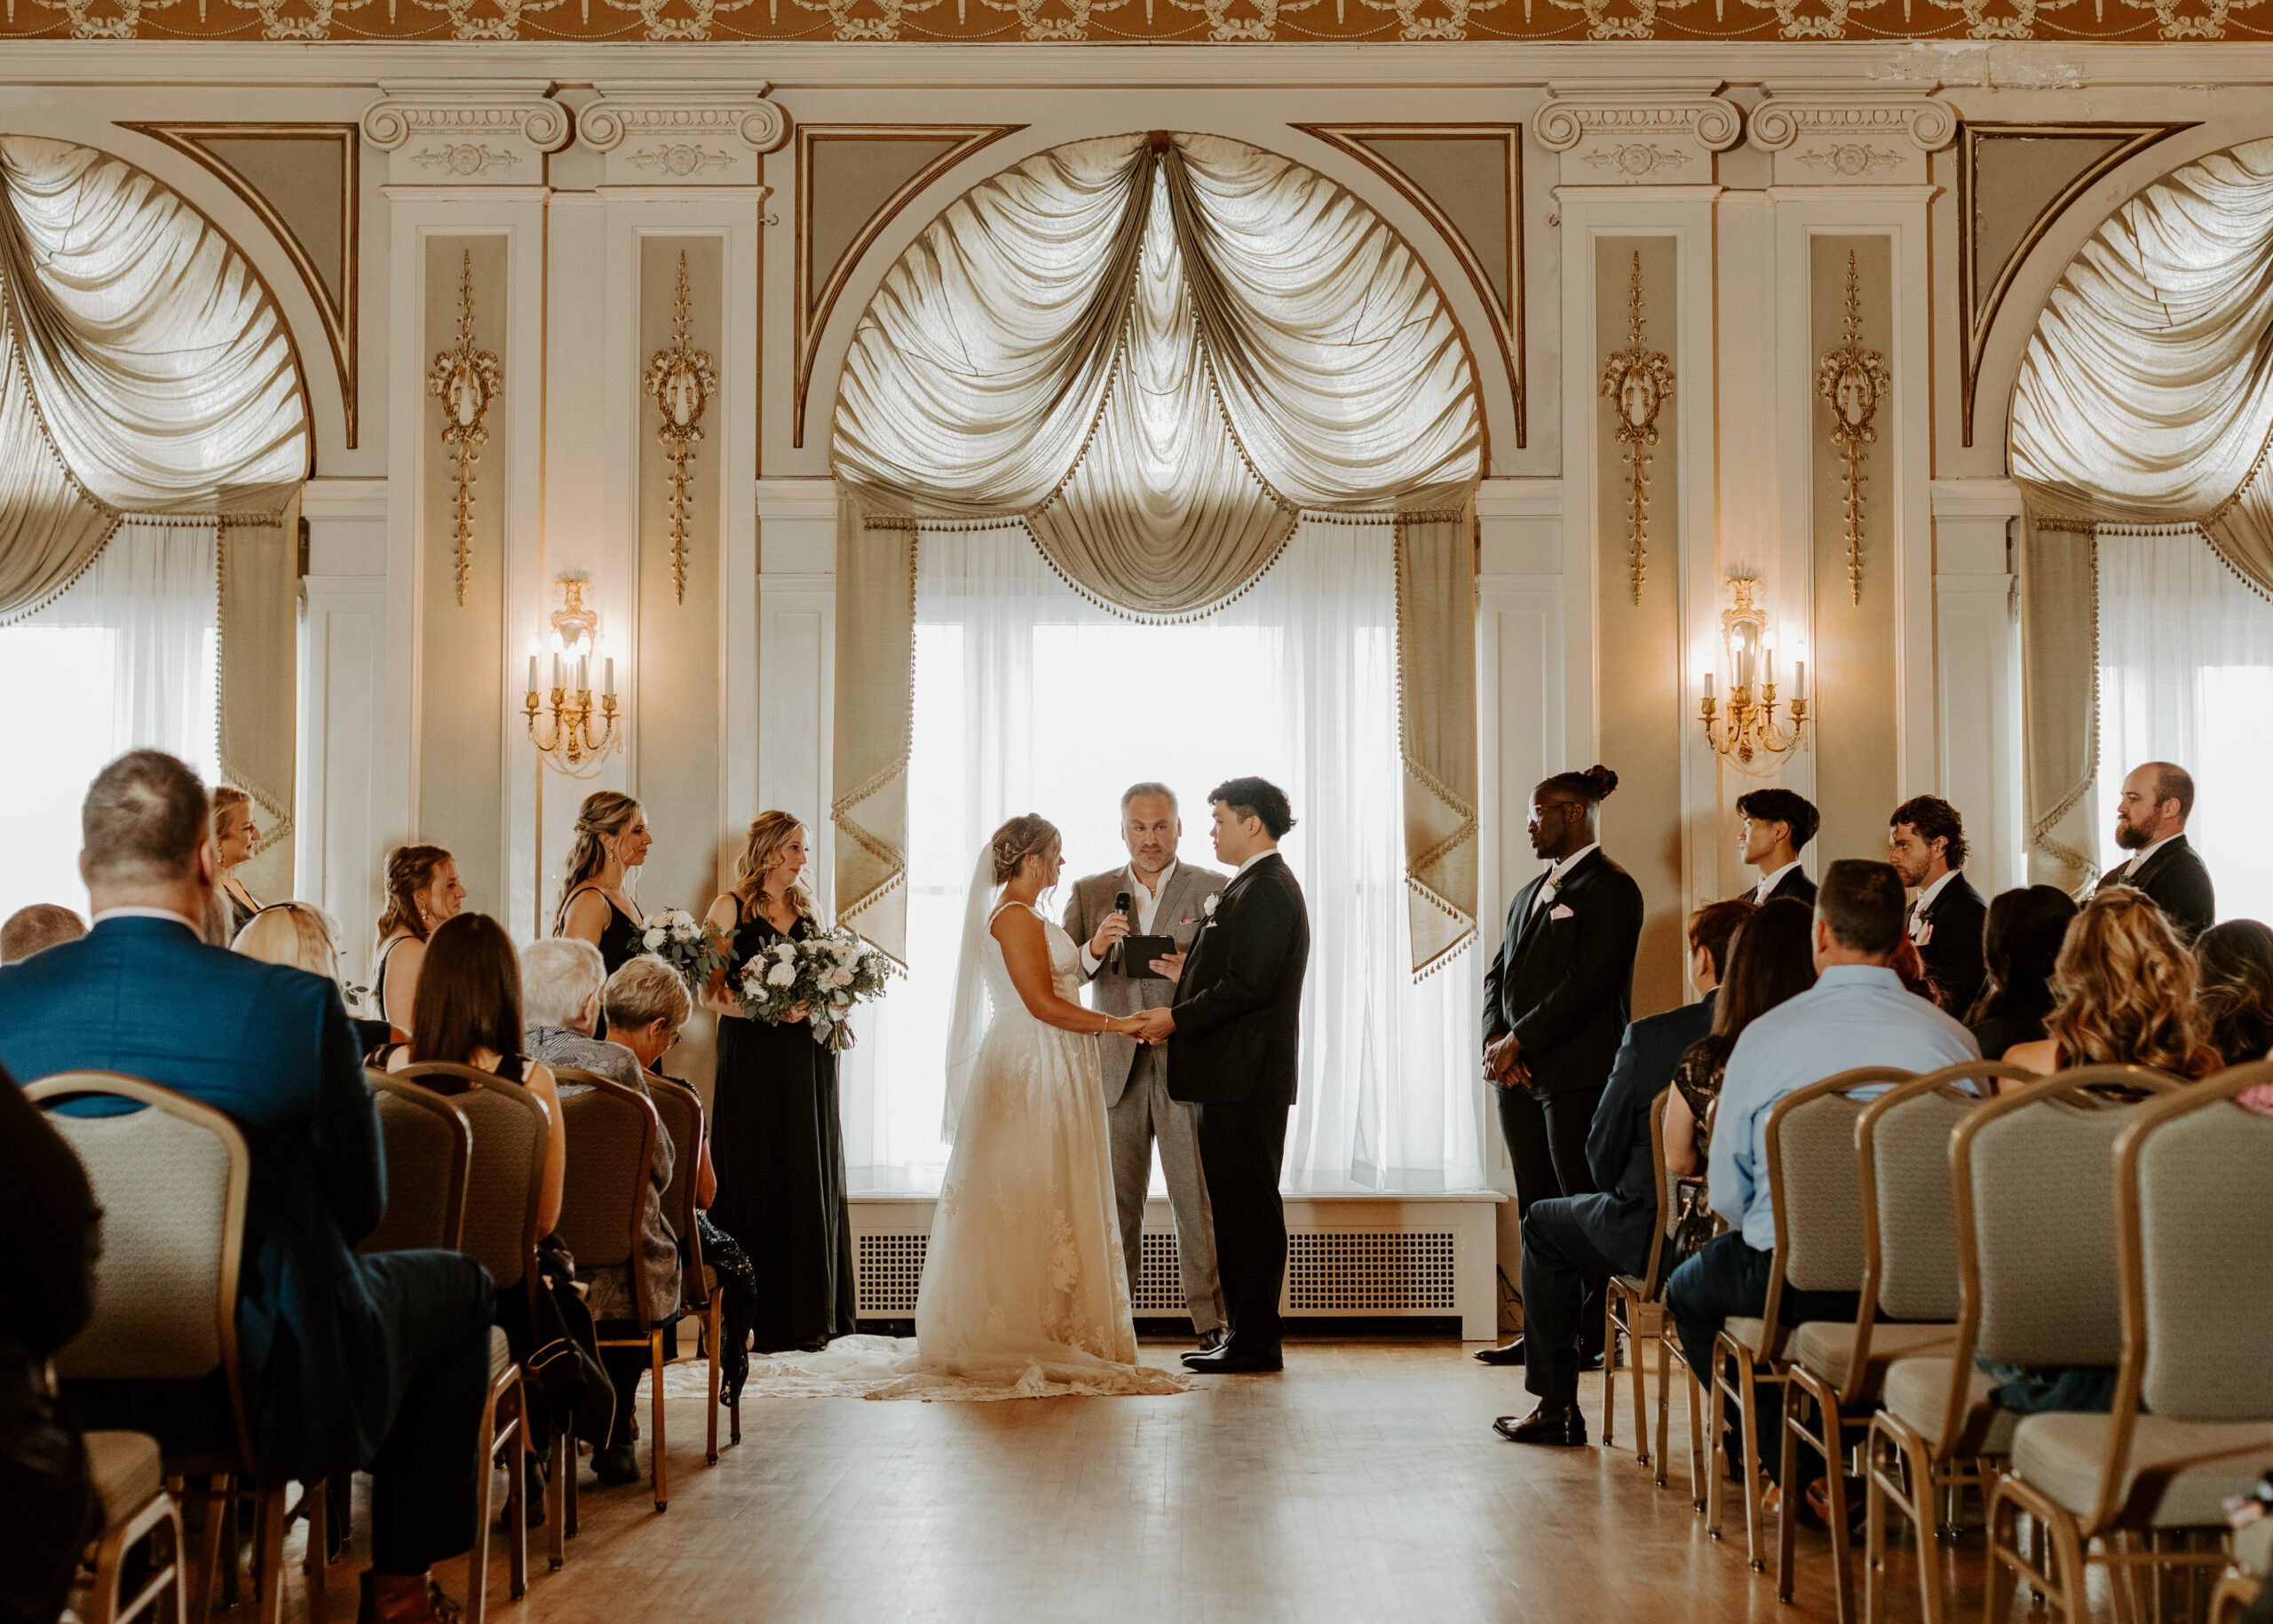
[23,1072,281,1624]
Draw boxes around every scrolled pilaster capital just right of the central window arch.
[1532,80,1744,186]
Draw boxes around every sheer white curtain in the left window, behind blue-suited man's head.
[0,519,218,916]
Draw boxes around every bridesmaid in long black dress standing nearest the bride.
[705,812,855,1353]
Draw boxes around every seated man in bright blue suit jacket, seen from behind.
[0,750,491,1621]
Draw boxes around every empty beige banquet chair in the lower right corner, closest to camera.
[1989,1062,2273,1621]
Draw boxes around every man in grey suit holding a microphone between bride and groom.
[1064,782,1223,1346]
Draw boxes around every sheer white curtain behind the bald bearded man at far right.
[2091,530,2273,919]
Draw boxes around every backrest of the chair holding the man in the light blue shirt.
[1766,1066,1916,1292]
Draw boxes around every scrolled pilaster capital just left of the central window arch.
[577,80,788,186]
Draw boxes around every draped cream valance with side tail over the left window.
[0,137,309,846]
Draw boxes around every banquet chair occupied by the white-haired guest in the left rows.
[552,1066,670,1510]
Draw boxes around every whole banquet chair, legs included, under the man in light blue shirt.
[1705,1066,1916,1574]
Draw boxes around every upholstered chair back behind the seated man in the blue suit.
[25,1072,252,1462]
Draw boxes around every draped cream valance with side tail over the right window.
[2012,139,2273,887]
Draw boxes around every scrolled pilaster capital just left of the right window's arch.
[1748,80,1957,186]
